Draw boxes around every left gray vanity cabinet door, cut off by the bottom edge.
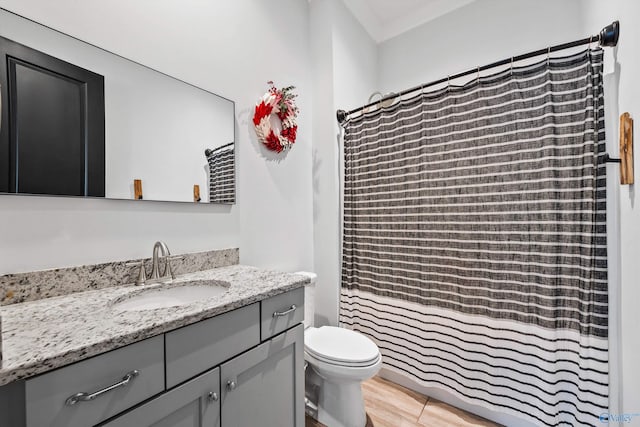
[101,368,220,427]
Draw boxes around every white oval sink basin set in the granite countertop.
[112,281,229,311]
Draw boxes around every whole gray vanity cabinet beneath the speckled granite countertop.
[0,289,304,427]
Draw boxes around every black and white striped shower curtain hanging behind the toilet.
[340,49,608,426]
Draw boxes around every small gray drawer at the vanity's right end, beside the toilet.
[260,287,304,341]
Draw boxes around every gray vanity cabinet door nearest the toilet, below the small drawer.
[220,324,304,427]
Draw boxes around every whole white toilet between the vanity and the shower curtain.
[296,272,382,427]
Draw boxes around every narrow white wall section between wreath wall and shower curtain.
[311,0,377,325]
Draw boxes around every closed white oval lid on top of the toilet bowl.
[304,326,380,365]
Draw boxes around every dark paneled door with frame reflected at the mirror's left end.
[0,37,105,197]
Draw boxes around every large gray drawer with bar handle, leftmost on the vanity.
[25,335,164,427]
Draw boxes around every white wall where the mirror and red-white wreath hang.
[0,0,313,273]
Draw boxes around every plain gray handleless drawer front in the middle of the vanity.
[165,303,260,389]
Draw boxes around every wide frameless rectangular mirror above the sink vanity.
[0,9,235,203]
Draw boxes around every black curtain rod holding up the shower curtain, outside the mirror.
[336,21,620,125]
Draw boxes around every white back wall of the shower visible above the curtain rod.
[378,0,585,93]
